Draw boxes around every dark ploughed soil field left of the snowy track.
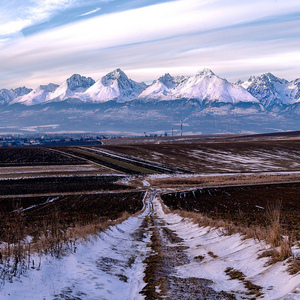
[0,192,144,241]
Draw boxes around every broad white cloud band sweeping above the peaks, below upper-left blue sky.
[0,0,300,85]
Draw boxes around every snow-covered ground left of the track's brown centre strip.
[0,203,149,300]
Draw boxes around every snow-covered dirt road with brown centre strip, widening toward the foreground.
[0,186,300,300]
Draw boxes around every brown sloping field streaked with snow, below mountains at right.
[98,139,300,174]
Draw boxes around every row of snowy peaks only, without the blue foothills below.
[0,69,300,107]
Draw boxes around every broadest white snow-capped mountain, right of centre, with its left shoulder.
[139,69,258,103]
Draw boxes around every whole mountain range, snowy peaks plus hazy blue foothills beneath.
[0,69,300,133]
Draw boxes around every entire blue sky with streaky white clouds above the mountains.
[0,0,300,89]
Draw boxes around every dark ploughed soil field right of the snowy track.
[162,183,300,239]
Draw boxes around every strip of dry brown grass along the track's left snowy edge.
[0,212,140,287]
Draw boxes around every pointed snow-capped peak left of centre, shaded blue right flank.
[83,69,147,102]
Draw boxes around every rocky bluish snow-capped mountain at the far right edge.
[237,73,300,106]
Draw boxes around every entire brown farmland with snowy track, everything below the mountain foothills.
[0,135,300,299]
